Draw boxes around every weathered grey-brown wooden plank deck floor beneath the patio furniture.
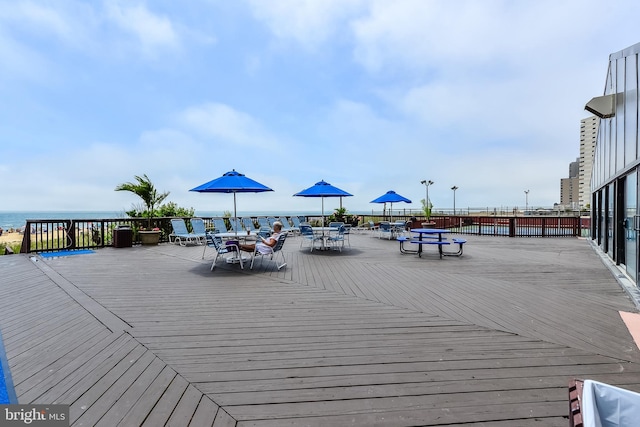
[0,234,640,427]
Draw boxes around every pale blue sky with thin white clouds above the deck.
[0,0,640,216]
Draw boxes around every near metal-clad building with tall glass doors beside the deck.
[585,43,640,285]
